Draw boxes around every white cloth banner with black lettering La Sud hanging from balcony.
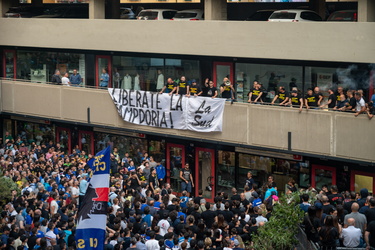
[108,88,225,132]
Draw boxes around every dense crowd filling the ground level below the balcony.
[0,133,375,250]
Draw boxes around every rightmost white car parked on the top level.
[268,10,322,22]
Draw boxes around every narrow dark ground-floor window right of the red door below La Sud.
[217,150,235,194]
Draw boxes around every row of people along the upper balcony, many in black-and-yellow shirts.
[52,68,375,119]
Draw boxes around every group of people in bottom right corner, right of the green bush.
[300,185,375,250]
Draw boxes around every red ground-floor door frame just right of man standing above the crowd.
[194,147,216,202]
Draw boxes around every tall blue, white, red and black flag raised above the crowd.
[76,147,111,250]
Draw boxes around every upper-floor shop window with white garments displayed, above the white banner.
[113,56,200,91]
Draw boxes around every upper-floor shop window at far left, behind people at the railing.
[17,51,86,84]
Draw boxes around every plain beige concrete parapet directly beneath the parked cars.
[0,18,375,63]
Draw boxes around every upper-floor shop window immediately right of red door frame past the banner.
[235,63,303,102]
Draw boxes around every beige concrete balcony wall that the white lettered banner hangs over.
[0,80,375,164]
